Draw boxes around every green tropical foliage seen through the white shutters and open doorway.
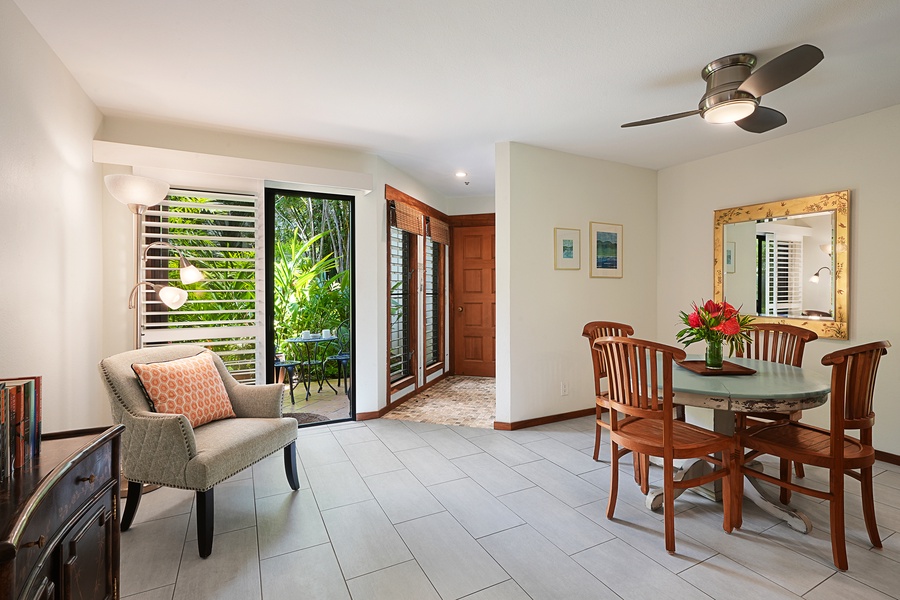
[148,195,351,370]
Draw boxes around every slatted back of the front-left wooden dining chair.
[594,336,685,427]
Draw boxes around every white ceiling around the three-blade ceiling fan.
[15,0,900,197]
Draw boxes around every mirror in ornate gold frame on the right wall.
[713,190,850,340]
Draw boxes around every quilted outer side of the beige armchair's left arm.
[122,411,197,487]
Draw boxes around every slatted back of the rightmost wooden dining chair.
[822,341,891,432]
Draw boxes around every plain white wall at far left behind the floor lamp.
[0,0,104,432]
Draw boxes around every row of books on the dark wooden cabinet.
[0,376,41,481]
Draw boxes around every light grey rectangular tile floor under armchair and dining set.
[121,417,900,600]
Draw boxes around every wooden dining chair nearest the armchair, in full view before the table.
[594,337,737,553]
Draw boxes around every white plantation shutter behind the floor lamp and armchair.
[138,190,265,383]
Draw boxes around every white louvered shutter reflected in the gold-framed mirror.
[763,233,803,317]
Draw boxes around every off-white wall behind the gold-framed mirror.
[656,105,900,454]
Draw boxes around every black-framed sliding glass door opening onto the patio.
[265,188,356,426]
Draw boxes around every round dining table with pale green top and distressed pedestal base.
[647,356,831,533]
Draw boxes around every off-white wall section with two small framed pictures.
[496,142,657,422]
